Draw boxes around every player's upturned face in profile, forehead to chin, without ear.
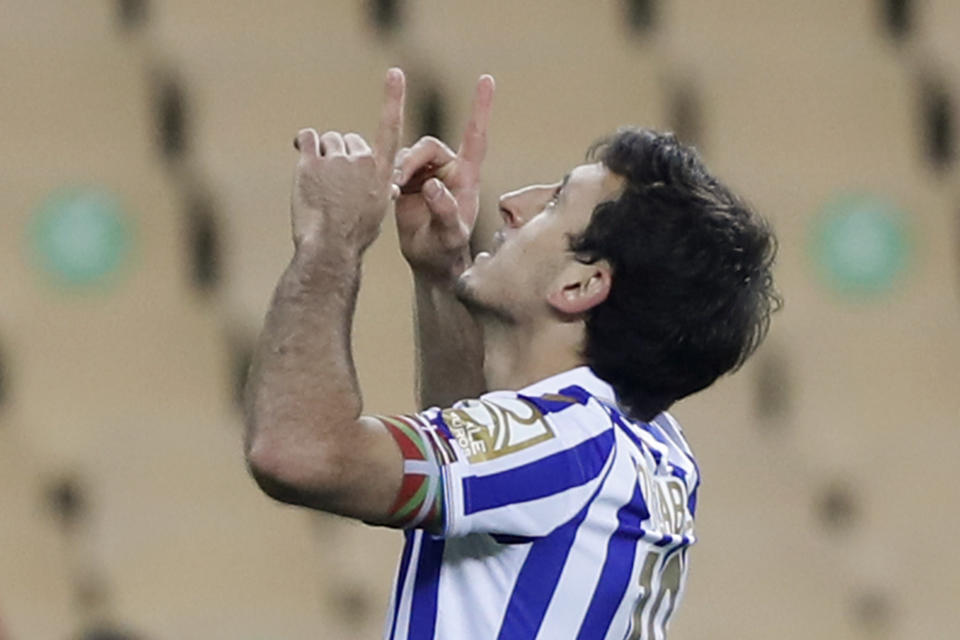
[457,162,623,322]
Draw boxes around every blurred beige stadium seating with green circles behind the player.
[0,0,960,640]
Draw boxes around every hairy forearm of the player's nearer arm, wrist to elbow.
[244,243,362,476]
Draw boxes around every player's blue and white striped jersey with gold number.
[384,367,700,640]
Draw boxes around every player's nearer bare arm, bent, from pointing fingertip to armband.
[244,70,404,524]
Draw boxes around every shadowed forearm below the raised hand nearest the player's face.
[414,264,486,408]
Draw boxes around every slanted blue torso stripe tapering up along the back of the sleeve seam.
[497,470,609,640]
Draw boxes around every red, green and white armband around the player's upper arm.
[377,416,444,532]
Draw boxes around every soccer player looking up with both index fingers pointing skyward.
[246,69,778,640]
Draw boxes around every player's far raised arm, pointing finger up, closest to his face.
[394,75,494,408]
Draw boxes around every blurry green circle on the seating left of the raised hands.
[30,187,130,286]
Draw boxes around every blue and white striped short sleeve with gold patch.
[426,388,615,537]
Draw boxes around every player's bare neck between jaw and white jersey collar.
[483,319,584,391]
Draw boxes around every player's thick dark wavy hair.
[570,128,782,420]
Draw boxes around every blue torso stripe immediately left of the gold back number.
[577,484,650,640]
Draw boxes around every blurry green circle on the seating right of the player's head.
[812,194,910,295]
